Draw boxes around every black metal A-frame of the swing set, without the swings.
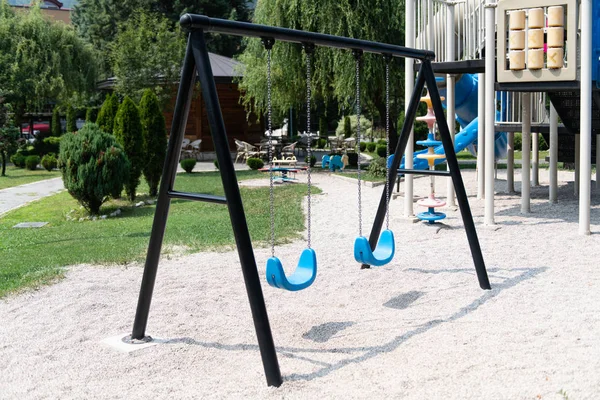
[131,14,490,386]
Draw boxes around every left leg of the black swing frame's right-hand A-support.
[361,68,428,269]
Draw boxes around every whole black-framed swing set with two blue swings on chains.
[131,14,490,386]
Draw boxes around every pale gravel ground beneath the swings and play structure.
[0,167,600,399]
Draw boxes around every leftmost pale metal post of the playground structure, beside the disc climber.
[400,0,416,218]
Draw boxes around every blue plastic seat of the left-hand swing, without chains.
[267,249,317,292]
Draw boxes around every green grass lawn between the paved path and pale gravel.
[0,171,320,297]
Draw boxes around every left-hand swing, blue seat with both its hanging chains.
[266,48,317,292]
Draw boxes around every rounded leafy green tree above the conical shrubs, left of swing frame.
[110,12,185,104]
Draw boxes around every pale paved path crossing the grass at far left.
[0,178,65,215]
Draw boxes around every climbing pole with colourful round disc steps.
[417,95,446,224]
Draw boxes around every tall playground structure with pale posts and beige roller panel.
[401,0,600,234]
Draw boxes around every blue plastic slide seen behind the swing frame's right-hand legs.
[388,74,507,169]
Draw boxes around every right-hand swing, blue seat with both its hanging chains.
[354,54,396,267]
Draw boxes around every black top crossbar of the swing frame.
[179,14,435,61]
